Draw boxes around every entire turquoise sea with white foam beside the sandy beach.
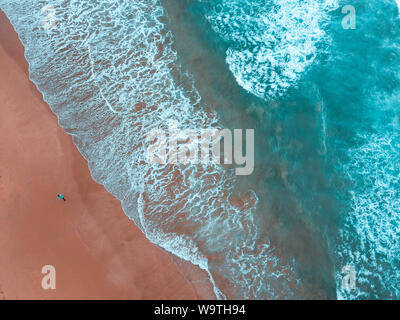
[0,0,400,299]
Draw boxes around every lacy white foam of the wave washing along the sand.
[0,0,304,298]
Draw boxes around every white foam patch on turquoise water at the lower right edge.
[336,132,400,299]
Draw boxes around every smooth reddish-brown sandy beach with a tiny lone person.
[0,12,215,299]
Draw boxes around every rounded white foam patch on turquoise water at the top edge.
[200,0,337,99]
